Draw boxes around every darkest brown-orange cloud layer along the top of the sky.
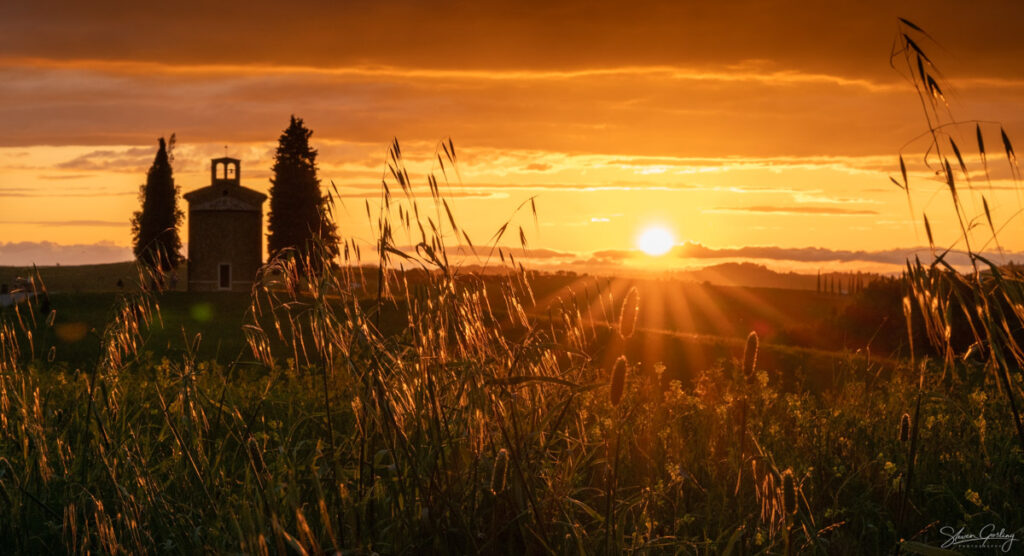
[6,0,1024,84]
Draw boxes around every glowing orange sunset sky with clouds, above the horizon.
[0,0,1024,272]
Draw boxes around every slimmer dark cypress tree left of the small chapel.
[131,134,184,270]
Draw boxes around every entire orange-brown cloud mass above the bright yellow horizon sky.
[0,0,1024,168]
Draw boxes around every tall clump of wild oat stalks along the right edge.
[891,18,1024,448]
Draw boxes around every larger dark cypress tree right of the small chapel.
[267,116,338,266]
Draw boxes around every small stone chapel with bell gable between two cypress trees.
[184,158,266,292]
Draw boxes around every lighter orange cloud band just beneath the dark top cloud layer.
[0,58,966,158]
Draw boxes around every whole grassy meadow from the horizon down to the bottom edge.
[0,19,1024,555]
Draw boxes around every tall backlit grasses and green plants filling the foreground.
[0,260,1024,554]
